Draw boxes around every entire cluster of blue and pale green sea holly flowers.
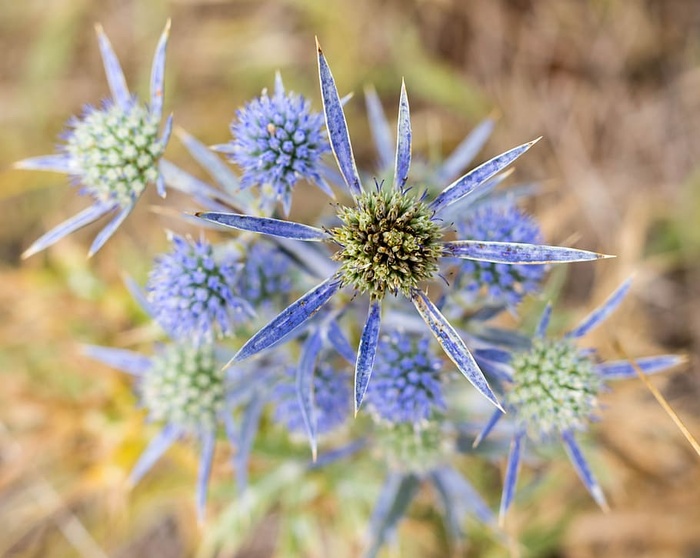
[18,20,680,555]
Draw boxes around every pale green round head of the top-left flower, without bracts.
[64,102,165,207]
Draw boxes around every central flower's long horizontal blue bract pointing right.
[443,240,612,265]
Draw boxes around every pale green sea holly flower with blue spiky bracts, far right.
[475,281,682,519]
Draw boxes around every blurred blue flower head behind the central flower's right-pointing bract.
[455,203,545,306]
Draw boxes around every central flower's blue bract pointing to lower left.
[229,277,341,364]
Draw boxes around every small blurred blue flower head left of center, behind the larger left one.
[236,242,292,308]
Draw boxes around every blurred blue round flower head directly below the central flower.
[367,332,445,424]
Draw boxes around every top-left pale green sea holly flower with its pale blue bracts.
[15,21,172,258]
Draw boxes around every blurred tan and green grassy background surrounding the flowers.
[0,0,700,558]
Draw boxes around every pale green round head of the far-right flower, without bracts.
[507,339,602,438]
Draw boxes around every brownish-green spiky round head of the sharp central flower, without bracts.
[329,187,442,300]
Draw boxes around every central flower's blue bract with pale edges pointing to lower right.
[411,289,505,412]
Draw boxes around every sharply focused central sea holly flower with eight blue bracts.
[197,40,605,413]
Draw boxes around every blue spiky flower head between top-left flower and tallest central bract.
[214,73,333,214]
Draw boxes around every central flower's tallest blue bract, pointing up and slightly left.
[316,40,362,196]
